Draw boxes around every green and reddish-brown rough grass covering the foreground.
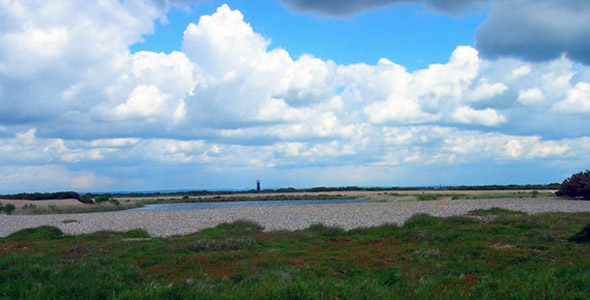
[0,209,590,299]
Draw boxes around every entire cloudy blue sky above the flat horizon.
[0,0,590,193]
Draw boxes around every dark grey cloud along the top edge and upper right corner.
[281,0,590,65]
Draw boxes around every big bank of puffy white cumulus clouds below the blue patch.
[0,1,590,191]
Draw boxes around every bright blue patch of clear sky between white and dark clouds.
[130,0,486,70]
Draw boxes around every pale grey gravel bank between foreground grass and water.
[0,198,590,237]
